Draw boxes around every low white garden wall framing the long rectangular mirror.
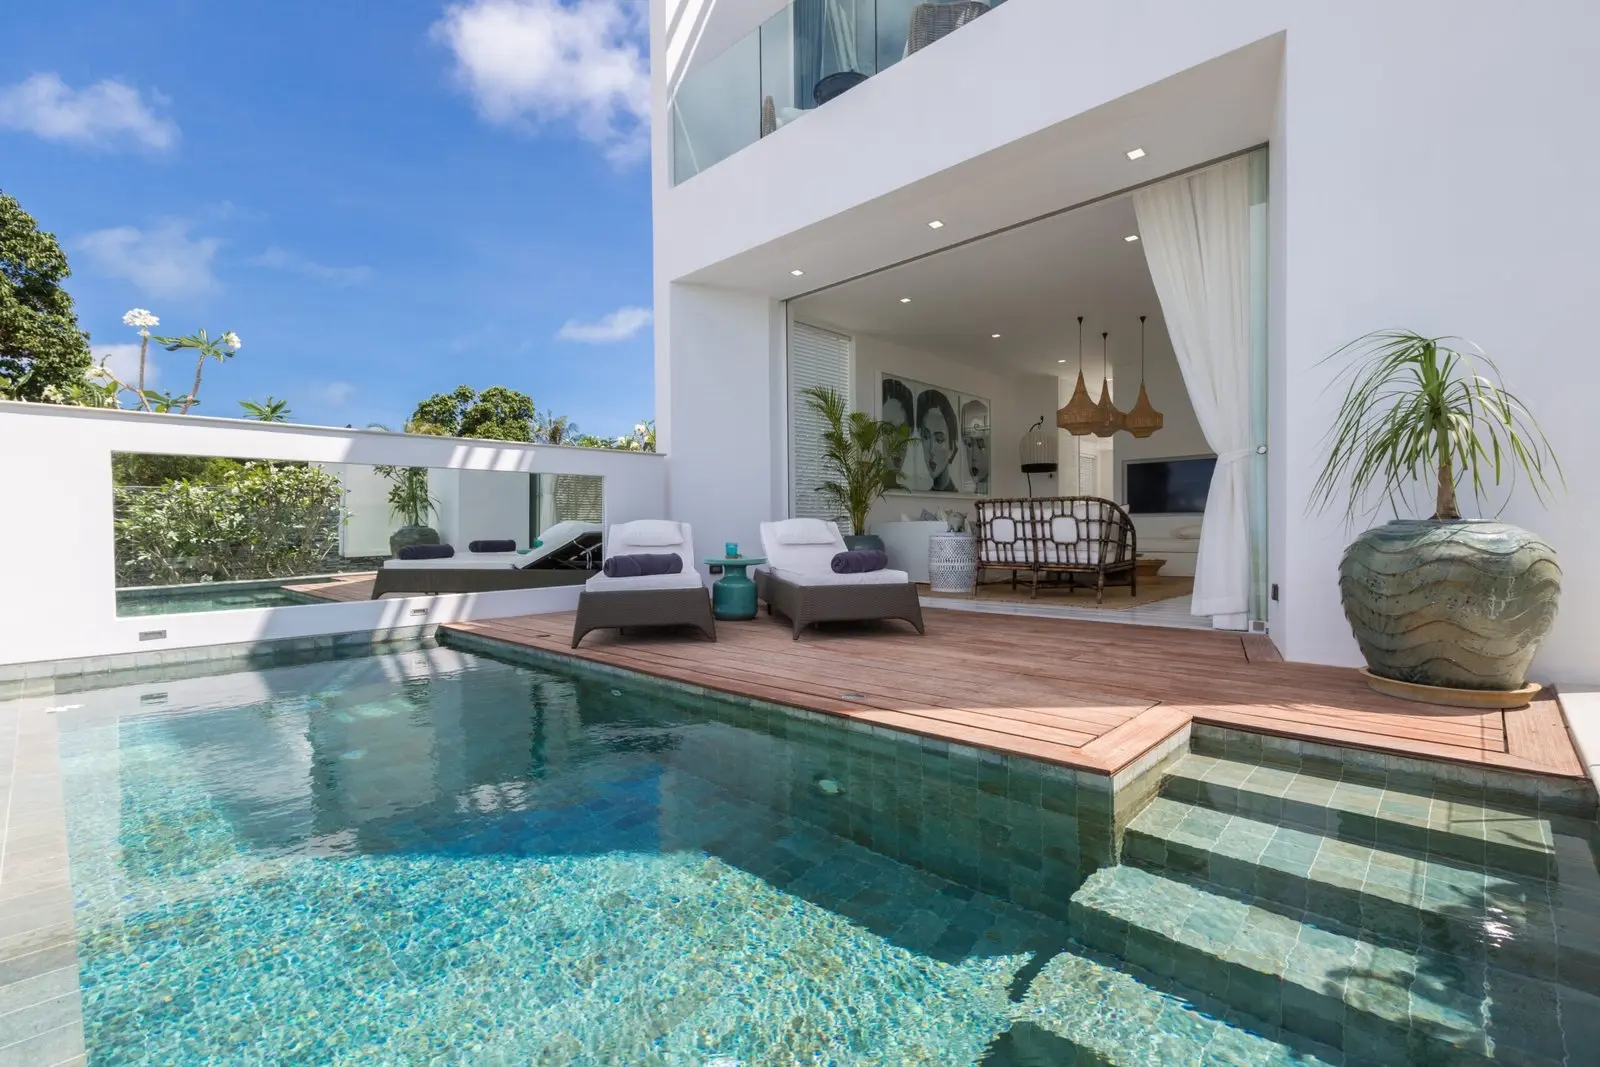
[0,402,667,664]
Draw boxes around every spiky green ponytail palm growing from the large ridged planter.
[1312,330,1565,520]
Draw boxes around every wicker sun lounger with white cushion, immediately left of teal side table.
[573,520,717,648]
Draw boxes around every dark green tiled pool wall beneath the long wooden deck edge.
[442,630,1187,918]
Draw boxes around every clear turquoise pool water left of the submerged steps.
[61,649,1113,1064]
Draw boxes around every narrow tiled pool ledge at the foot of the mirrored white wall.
[0,624,437,701]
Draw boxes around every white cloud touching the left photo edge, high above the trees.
[0,74,178,152]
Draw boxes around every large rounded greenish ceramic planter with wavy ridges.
[1339,520,1562,699]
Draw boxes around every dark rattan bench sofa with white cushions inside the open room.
[973,496,1139,603]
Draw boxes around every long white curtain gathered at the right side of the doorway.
[1133,157,1254,629]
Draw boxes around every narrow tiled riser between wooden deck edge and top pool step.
[1189,723,1597,819]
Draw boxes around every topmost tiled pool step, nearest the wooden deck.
[1162,753,1555,878]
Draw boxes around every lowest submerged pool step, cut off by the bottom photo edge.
[1004,952,1341,1067]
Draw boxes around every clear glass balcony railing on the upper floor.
[669,0,1005,184]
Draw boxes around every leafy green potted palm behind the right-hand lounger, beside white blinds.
[802,386,910,549]
